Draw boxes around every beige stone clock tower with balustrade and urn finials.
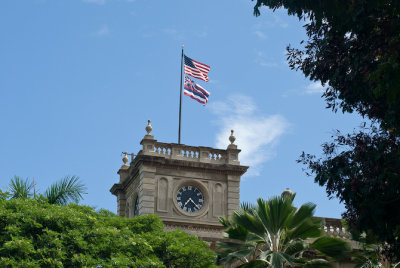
[110,120,248,241]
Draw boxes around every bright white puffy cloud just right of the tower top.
[210,95,289,176]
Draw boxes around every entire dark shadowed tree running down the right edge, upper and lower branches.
[250,0,400,261]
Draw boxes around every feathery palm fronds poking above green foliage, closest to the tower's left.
[44,176,86,205]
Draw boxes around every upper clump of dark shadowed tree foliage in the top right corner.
[254,0,400,133]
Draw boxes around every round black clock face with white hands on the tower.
[176,185,204,213]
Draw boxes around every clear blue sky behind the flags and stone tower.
[0,0,361,217]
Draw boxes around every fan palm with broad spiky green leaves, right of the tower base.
[219,194,350,268]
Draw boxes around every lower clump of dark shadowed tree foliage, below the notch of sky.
[299,128,400,261]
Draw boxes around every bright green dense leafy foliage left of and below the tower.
[0,199,215,267]
